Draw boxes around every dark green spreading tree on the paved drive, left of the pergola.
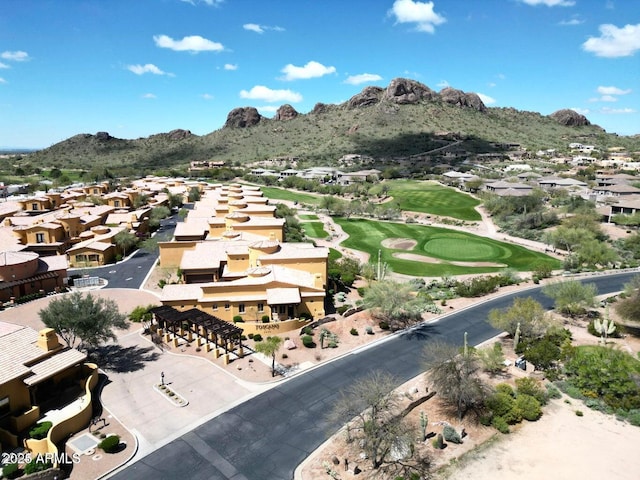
[38,292,127,350]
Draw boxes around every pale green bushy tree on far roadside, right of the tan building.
[362,280,434,330]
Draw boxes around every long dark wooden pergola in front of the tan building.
[149,305,242,353]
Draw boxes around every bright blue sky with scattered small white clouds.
[0,0,640,148]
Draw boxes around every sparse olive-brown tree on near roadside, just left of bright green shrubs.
[424,342,491,420]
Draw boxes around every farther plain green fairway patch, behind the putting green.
[388,180,482,222]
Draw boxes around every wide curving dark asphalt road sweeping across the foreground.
[109,272,637,480]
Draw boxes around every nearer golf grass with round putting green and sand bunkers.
[334,218,561,277]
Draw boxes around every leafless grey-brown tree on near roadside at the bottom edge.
[328,370,430,478]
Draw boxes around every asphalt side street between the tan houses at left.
[70,214,178,289]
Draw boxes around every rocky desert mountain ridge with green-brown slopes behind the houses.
[21,78,640,174]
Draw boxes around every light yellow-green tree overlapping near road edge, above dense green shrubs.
[489,297,552,339]
